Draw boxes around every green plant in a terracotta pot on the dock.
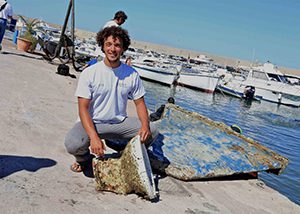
[17,16,39,52]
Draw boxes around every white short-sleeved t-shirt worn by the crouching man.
[75,61,145,123]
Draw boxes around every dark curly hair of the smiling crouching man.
[96,26,131,52]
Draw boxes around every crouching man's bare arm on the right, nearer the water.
[134,97,151,143]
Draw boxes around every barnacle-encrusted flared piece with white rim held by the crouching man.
[93,136,156,199]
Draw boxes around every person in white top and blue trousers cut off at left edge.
[0,0,13,51]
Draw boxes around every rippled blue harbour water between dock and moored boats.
[143,81,300,204]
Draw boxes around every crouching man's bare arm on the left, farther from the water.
[78,97,105,156]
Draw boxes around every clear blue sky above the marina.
[8,0,300,70]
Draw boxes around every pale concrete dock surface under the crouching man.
[0,40,300,214]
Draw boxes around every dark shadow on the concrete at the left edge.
[0,155,57,178]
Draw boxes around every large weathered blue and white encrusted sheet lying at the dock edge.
[153,104,288,180]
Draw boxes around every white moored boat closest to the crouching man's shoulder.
[132,57,178,85]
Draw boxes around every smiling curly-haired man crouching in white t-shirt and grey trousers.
[65,26,158,175]
